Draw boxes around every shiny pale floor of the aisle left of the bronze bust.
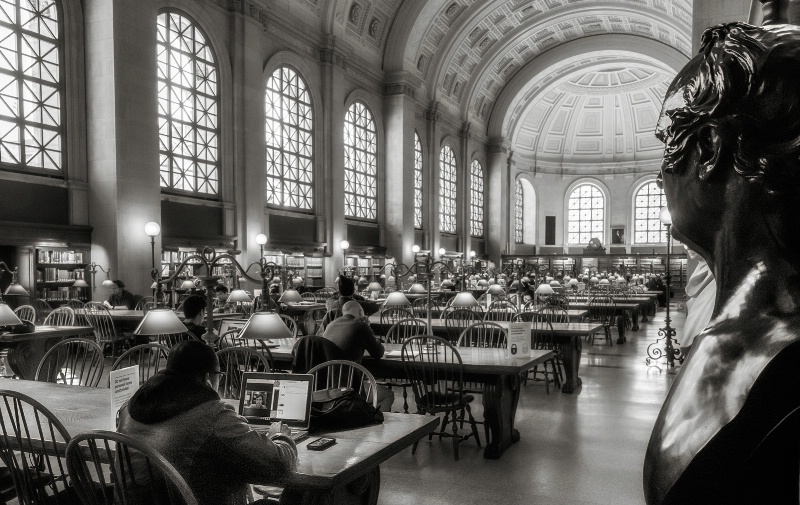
[378,303,686,505]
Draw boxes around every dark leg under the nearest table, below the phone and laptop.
[280,466,381,505]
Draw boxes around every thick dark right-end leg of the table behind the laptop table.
[483,374,521,459]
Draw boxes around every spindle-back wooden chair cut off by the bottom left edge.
[0,390,74,505]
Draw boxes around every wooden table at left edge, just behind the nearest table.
[0,326,94,380]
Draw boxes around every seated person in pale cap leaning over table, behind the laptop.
[322,300,394,412]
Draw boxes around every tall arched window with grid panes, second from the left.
[156,11,219,195]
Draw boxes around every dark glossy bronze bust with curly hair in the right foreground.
[644,18,800,505]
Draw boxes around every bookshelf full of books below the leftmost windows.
[33,247,91,307]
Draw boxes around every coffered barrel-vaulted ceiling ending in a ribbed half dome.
[262,0,692,173]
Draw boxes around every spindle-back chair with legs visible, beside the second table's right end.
[401,335,481,459]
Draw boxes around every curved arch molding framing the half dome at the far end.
[484,34,689,138]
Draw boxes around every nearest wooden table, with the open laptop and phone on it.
[0,380,439,505]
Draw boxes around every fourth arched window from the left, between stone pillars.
[344,102,378,220]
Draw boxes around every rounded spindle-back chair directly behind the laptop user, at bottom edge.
[66,430,202,505]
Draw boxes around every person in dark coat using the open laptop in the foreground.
[118,340,297,505]
